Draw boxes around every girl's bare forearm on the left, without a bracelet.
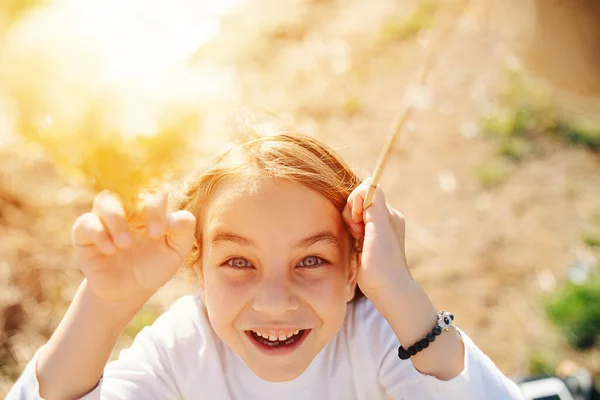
[36,281,142,400]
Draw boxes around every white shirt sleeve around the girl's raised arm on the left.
[7,301,199,400]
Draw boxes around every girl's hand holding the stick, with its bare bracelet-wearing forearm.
[342,179,464,380]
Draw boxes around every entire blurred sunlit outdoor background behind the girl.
[0,0,600,395]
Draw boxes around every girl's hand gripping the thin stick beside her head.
[342,178,412,300]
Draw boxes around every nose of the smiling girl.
[252,275,300,317]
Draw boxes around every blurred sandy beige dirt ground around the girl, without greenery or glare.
[0,0,600,394]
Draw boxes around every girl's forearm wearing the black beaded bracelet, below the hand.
[371,277,464,380]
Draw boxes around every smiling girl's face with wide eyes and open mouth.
[200,180,356,382]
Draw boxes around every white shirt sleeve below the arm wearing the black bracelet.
[354,301,522,400]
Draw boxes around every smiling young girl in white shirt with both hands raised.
[8,130,520,400]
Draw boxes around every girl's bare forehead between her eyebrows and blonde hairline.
[202,178,342,237]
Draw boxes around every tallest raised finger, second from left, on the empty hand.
[92,190,131,248]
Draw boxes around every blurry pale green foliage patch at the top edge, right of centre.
[379,0,438,42]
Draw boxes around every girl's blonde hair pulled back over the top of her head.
[178,132,361,298]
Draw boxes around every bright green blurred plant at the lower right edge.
[546,277,600,349]
